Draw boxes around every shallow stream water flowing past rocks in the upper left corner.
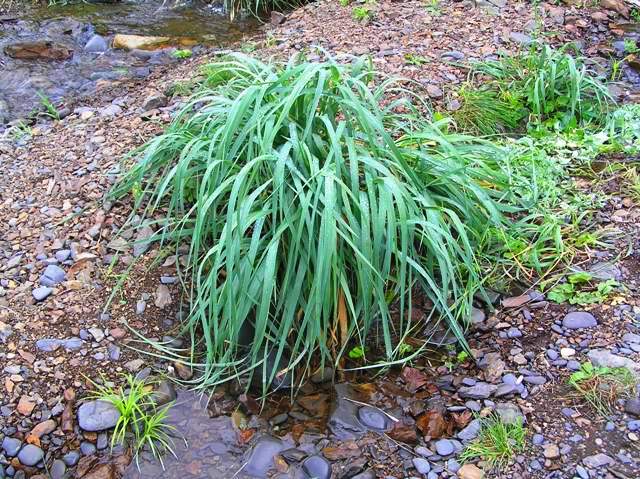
[0,0,257,125]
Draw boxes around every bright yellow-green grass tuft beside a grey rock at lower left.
[89,374,175,463]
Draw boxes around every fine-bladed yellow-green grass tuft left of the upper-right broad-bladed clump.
[452,83,526,135]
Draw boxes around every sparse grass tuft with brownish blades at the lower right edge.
[569,362,637,417]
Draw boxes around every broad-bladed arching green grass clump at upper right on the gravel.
[472,44,612,131]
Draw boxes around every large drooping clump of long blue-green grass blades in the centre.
[112,55,502,391]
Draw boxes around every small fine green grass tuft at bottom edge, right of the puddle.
[460,414,526,469]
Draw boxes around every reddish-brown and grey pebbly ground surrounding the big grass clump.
[0,0,640,479]
